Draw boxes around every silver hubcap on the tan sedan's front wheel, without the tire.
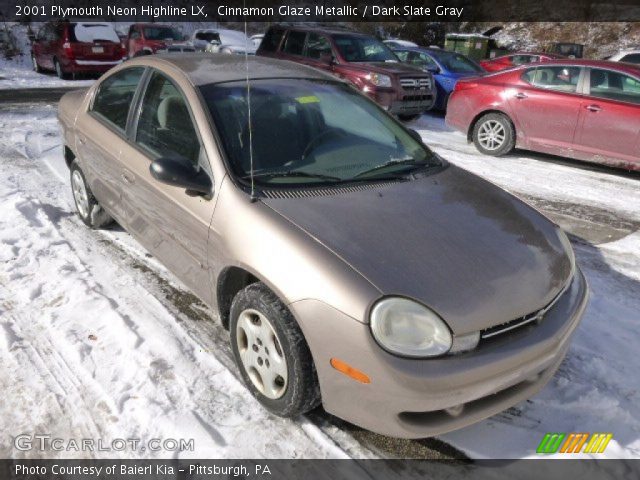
[236,309,288,400]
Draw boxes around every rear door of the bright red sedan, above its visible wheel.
[505,64,583,155]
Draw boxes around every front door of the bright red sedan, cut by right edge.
[578,68,640,164]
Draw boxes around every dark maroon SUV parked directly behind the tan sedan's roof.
[257,25,436,120]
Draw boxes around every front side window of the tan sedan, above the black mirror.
[136,72,201,165]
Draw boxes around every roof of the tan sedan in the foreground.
[132,52,339,86]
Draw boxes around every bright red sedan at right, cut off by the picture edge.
[446,60,640,170]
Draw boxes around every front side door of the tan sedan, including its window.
[121,70,213,301]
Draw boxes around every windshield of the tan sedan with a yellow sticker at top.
[200,79,441,186]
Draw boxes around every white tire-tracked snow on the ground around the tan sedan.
[0,106,640,458]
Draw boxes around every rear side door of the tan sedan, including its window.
[76,67,145,222]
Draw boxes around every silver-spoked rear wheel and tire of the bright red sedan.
[471,113,516,157]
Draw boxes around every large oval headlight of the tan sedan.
[371,297,452,357]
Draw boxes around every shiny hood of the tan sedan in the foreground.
[265,166,571,334]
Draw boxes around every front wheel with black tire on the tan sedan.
[229,283,320,418]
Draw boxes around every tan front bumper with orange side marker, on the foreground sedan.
[290,270,588,438]
